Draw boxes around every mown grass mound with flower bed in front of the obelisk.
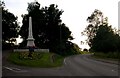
[8,52,64,68]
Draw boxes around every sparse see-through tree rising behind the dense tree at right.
[82,9,107,47]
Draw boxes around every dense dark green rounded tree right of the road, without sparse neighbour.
[91,25,120,52]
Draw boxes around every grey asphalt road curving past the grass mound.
[2,50,118,76]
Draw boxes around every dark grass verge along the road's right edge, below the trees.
[92,52,120,61]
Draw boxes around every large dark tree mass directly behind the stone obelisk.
[19,1,73,52]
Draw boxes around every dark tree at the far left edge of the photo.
[0,1,19,47]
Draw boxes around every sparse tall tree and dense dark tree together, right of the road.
[82,9,120,52]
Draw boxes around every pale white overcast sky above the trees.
[4,0,119,48]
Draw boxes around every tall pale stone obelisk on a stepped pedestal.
[27,17,35,47]
